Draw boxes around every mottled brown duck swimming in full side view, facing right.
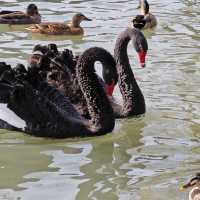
[26,13,91,35]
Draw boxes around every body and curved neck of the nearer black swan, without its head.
[0,47,115,138]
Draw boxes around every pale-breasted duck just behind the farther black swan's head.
[139,0,157,29]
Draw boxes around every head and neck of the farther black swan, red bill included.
[114,28,148,117]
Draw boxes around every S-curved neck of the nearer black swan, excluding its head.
[76,47,115,134]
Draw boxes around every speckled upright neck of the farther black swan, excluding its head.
[114,28,145,117]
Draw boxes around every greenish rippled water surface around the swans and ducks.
[0,0,200,200]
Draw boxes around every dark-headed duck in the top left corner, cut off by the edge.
[0,4,41,24]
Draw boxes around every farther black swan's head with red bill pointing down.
[132,28,148,67]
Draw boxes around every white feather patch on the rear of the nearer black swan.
[0,103,26,130]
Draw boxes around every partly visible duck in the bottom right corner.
[181,173,200,200]
